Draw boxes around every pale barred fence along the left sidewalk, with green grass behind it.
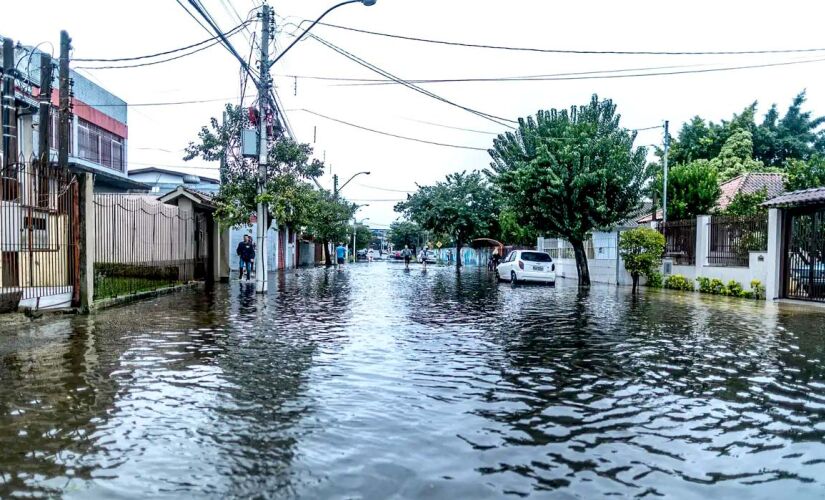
[94,194,208,300]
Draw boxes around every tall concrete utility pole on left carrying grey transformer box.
[255,3,270,293]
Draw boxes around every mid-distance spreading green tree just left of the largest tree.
[395,171,499,267]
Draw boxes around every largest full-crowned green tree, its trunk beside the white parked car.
[490,95,649,286]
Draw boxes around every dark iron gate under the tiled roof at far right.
[783,208,825,301]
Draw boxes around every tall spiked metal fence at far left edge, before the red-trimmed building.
[0,160,80,311]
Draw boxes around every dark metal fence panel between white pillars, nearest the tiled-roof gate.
[708,214,768,267]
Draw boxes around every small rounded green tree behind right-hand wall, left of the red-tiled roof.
[667,160,722,220]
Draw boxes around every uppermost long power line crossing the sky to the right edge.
[314,20,825,56]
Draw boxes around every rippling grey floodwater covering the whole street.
[0,263,825,499]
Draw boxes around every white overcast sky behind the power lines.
[0,0,825,227]
